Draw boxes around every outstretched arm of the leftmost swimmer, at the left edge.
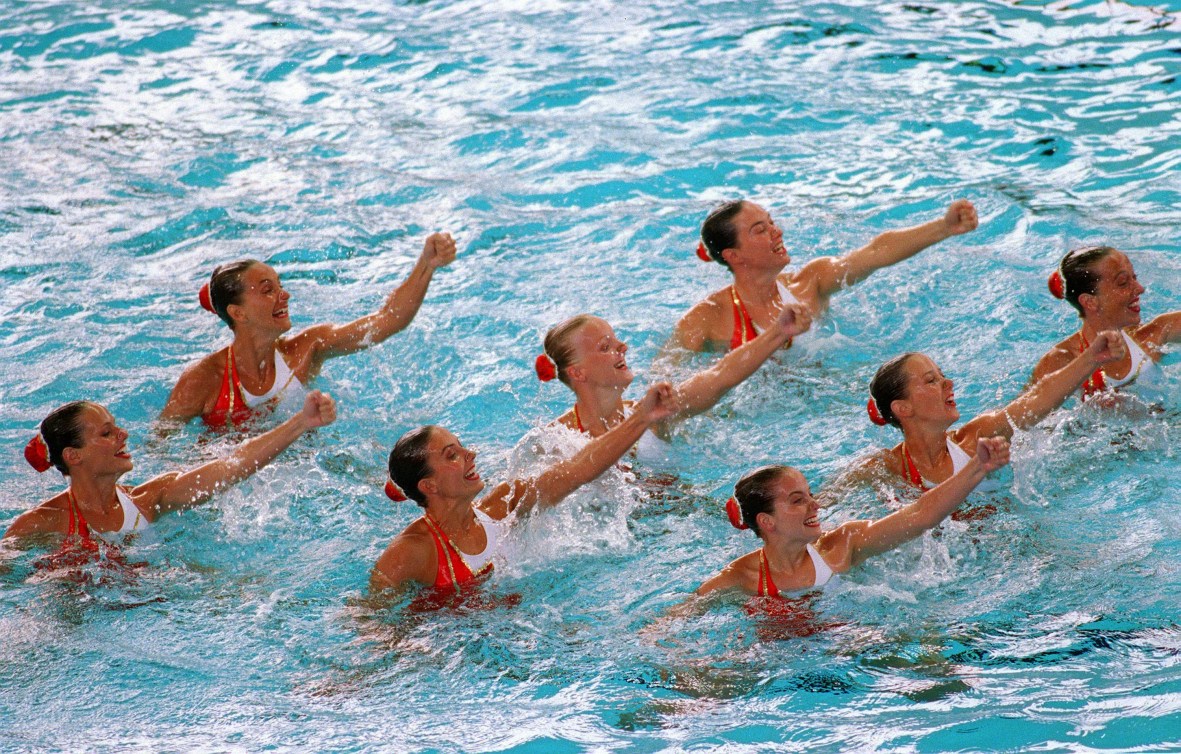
[132,390,337,520]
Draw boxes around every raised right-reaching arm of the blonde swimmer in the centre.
[674,304,811,418]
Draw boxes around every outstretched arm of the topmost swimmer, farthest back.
[801,199,979,298]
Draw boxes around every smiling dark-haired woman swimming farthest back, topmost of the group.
[672,200,978,351]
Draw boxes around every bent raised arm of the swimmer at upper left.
[299,233,456,364]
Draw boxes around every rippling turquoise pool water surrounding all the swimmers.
[0,0,1181,752]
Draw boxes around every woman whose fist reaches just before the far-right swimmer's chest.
[866,330,1127,489]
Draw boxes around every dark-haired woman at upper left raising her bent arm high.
[159,233,456,428]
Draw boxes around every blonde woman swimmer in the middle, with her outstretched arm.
[537,304,811,447]
